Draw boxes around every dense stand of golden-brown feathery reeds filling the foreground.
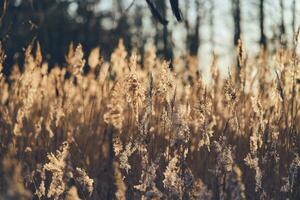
[0,40,300,200]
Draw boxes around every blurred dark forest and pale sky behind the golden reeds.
[0,0,300,76]
